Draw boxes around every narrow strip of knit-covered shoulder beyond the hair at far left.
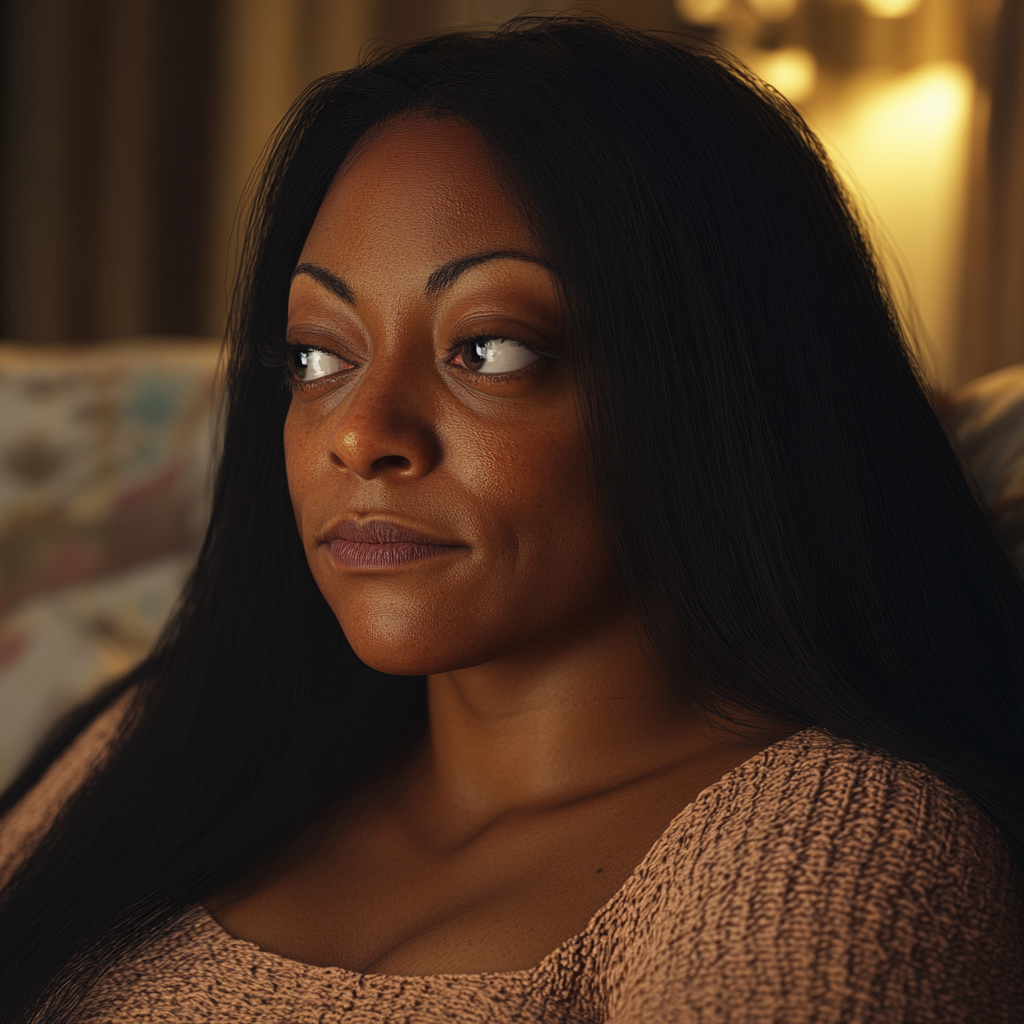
[0,691,133,886]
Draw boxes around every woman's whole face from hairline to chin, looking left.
[285,117,622,675]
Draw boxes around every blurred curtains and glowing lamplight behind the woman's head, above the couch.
[0,0,1024,384]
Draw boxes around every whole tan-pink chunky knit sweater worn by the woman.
[0,713,1024,1024]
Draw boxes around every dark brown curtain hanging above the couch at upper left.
[0,0,215,341]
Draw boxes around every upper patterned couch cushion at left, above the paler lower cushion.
[0,338,220,614]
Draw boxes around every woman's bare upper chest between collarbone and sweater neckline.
[213,780,712,975]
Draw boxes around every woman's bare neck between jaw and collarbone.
[407,615,782,835]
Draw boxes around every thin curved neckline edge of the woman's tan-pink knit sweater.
[196,726,820,985]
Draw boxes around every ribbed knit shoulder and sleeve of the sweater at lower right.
[611,729,1024,1024]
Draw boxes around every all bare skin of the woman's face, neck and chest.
[210,116,793,975]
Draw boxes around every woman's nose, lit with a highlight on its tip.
[328,358,440,480]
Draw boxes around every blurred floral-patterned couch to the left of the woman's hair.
[0,338,220,786]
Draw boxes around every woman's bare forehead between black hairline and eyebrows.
[300,116,540,274]
